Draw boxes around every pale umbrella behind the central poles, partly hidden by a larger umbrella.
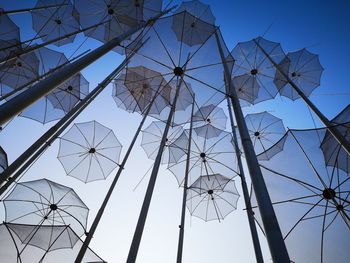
[141,121,185,164]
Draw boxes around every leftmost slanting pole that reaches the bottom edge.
[75,77,163,263]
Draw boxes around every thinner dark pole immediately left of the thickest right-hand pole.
[227,98,264,263]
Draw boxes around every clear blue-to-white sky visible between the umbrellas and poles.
[0,0,350,263]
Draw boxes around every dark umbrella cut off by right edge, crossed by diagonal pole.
[321,105,350,173]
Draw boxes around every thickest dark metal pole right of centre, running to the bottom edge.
[215,29,290,263]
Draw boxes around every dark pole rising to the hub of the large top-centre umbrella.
[126,77,181,263]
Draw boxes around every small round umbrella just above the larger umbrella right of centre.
[193,104,227,138]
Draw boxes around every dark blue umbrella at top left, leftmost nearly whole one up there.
[31,0,80,46]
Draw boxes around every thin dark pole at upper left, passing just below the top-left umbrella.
[0,20,109,65]
